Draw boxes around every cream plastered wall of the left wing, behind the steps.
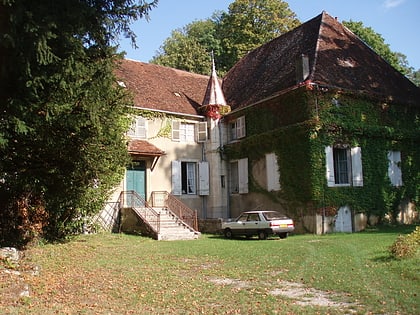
[105,113,228,222]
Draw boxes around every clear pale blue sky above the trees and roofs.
[119,0,420,70]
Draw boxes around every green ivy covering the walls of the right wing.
[224,87,420,221]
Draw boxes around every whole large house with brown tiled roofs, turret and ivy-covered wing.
[110,12,420,233]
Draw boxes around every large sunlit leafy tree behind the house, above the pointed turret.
[151,0,300,75]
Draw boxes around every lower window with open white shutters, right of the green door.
[172,161,209,195]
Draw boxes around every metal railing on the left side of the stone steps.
[119,190,160,234]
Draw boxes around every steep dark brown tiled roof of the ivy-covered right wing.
[222,12,420,109]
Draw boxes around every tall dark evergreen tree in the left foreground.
[0,0,157,245]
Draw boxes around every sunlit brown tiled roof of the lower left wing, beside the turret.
[116,59,209,115]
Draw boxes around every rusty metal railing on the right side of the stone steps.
[152,191,198,231]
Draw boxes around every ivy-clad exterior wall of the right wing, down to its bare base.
[221,89,420,233]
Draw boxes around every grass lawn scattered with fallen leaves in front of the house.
[0,227,420,314]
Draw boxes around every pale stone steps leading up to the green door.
[155,209,200,241]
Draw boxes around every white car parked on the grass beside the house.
[222,210,295,240]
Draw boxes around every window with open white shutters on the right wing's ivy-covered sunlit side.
[325,146,363,187]
